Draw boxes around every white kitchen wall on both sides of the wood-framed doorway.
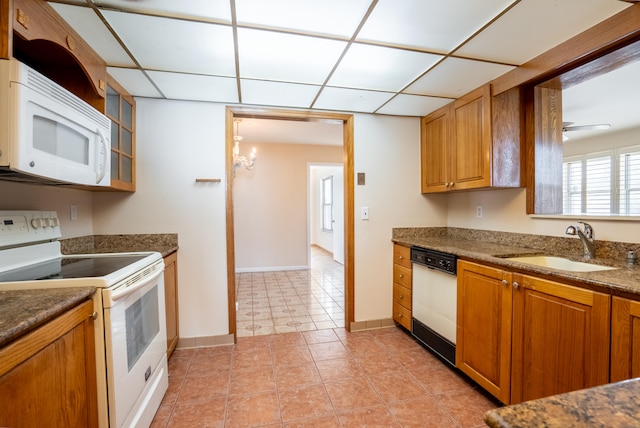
[93,99,446,337]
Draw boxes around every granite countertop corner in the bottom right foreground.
[484,379,640,428]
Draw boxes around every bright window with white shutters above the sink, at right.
[562,146,640,216]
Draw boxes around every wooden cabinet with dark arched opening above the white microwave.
[8,0,107,112]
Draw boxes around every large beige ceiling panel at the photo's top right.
[456,0,630,65]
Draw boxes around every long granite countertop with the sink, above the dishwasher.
[392,235,640,297]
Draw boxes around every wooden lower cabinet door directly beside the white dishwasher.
[456,261,512,403]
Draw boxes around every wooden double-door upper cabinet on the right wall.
[420,84,522,193]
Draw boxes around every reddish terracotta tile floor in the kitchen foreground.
[152,327,496,428]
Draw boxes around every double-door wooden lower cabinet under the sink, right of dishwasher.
[456,261,611,404]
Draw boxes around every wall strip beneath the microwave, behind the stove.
[0,181,93,238]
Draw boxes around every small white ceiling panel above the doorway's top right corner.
[314,87,393,113]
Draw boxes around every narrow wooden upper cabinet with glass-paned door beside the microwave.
[106,75,136,192]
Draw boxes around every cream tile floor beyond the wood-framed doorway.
[236,246,344,337]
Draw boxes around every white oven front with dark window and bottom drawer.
[103,269,168,427]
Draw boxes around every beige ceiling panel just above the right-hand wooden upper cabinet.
[404,58,515,98]
